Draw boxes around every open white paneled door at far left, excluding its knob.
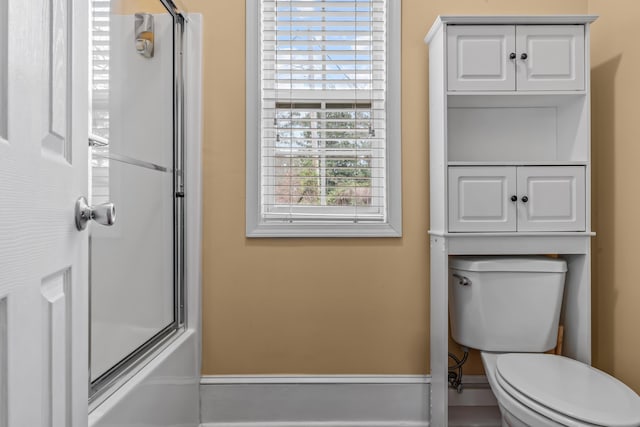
[0,0,88,427]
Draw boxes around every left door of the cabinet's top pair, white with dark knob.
[447,25,516,91]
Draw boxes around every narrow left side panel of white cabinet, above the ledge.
[429,27,447,231]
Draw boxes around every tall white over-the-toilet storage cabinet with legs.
[425,16,595,426]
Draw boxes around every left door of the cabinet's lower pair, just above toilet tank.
[449,166,516,232]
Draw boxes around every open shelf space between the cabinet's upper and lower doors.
[447,95,589,165]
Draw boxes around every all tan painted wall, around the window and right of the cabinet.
[107,0,640,392]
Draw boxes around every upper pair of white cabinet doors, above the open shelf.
[447,25,585,91]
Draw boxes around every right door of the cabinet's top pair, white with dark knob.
[516,25,585,90]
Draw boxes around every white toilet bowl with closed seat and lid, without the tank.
[481,352,640,427]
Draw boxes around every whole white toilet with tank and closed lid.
[449,257,640,427]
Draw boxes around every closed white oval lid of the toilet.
[496,353,640,427]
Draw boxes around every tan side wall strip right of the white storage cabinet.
[589,0,640,393]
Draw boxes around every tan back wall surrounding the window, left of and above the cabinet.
[176,0,587,374]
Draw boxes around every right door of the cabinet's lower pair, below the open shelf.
[518,166,585,231]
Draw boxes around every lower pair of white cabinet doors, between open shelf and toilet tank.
[448,166,585,232]
